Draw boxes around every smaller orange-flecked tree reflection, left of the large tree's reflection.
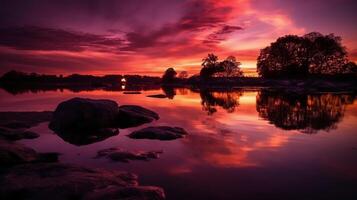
[200,90,242,115]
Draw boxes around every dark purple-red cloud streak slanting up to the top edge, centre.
[122,1,234,51]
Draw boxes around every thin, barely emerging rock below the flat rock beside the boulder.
[96,148,162,162]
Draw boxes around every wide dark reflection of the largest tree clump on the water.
[256,90,354,133]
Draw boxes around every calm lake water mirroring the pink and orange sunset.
[0,89,357,200]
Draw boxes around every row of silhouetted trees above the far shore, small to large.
[162,32,357,83]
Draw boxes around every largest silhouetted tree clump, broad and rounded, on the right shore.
[257,32,350,78]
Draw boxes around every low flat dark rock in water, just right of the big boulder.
[129,126,188,140]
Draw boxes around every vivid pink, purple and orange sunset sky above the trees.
[0,0,357,75]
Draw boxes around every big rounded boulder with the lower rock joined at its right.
[49,98,159,133]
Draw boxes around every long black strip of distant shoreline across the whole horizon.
[0,72,357,93]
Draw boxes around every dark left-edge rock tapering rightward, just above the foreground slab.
[0,140,58,166]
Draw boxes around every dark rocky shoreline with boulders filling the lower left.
[0,98,187,200]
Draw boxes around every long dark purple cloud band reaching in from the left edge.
[0,26,123,52]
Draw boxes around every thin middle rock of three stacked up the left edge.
[0,127,40,140]
